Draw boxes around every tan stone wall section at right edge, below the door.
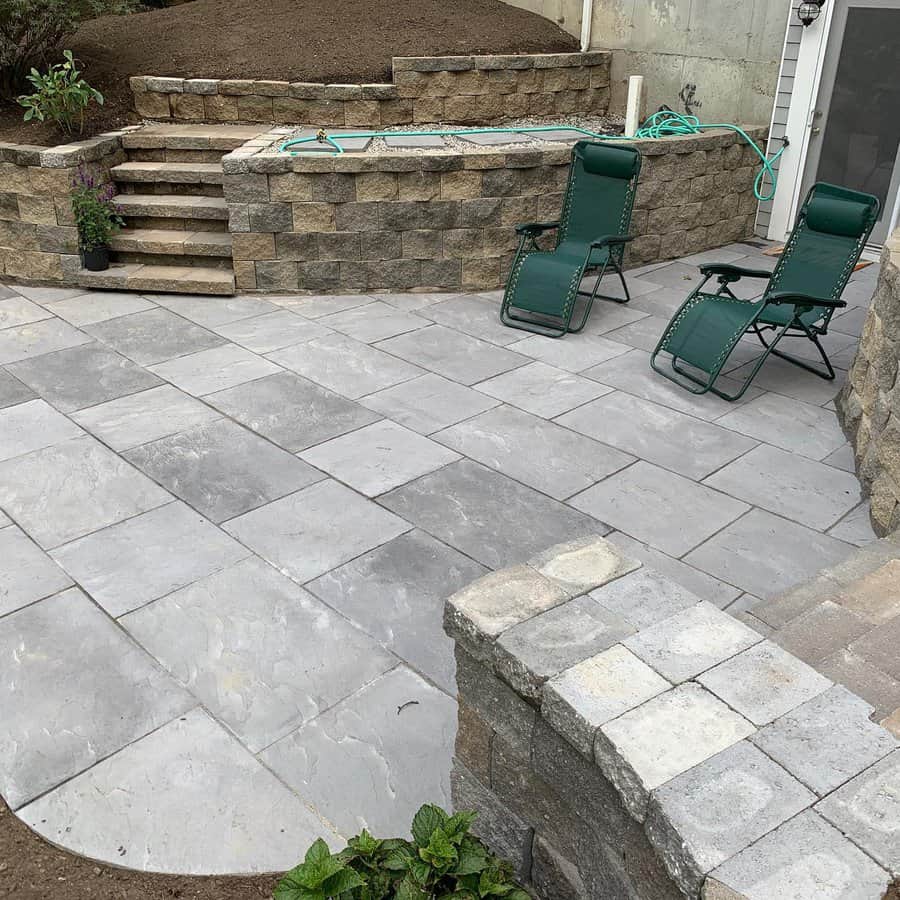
[837,230,900,534]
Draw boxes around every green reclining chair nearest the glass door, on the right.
[650,182,879,400]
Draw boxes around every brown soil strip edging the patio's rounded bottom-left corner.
[0,799,278,900]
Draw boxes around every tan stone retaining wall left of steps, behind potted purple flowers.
[0,132,125,282]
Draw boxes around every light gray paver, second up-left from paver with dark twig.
[52,503,250,616]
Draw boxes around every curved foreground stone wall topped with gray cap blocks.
[445,538,900,900]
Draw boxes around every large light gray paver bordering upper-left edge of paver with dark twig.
[121,557,396,752]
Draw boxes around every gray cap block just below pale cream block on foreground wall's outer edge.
[646,741,815,896]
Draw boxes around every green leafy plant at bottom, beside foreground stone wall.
[275,805,529,900]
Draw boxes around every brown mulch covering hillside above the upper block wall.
[0,0,578,146]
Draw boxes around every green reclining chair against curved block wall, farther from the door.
[500,141,641,337]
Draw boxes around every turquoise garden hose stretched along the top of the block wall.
[281,109,788,202]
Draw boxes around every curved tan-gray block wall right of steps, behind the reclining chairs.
[223,129,765,292]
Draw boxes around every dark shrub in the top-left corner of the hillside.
[0,0,134,100]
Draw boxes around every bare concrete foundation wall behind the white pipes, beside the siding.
[506,0,790,125]
